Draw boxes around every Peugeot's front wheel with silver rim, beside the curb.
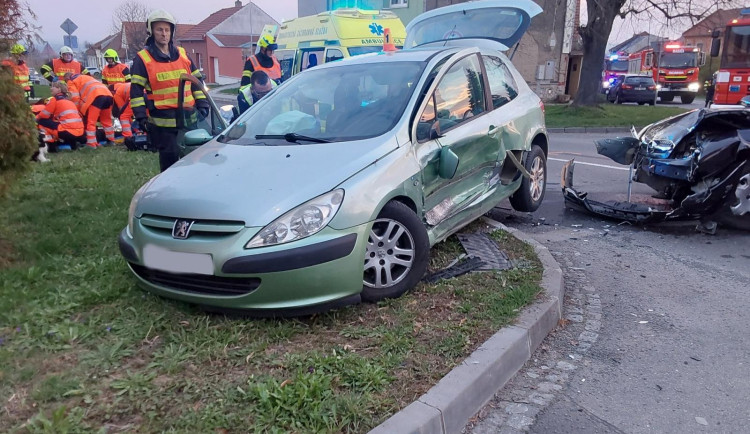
[362,201,430,302]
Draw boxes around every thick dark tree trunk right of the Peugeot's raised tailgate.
[573,0,625,106]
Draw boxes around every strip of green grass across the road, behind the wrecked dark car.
[545,104,688,128]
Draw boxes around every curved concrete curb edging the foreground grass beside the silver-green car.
[370,217,565,434]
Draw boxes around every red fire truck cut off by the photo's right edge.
[711,9,750,105]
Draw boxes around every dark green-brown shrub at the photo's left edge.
[0,67,38,195]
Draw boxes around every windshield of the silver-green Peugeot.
[218,61,425,146]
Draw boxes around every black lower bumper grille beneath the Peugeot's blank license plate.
[130,263,260,296]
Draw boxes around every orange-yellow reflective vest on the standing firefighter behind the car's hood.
[138,47,195,110]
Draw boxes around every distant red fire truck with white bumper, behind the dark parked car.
[628,42,706,104]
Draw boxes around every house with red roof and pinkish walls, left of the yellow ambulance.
[179,0,279,84]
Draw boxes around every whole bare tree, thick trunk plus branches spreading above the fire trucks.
[573,0,743,106]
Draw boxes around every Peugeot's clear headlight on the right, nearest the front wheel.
[250,189,344,249]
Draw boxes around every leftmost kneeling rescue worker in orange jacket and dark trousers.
[36,81,83,152]
